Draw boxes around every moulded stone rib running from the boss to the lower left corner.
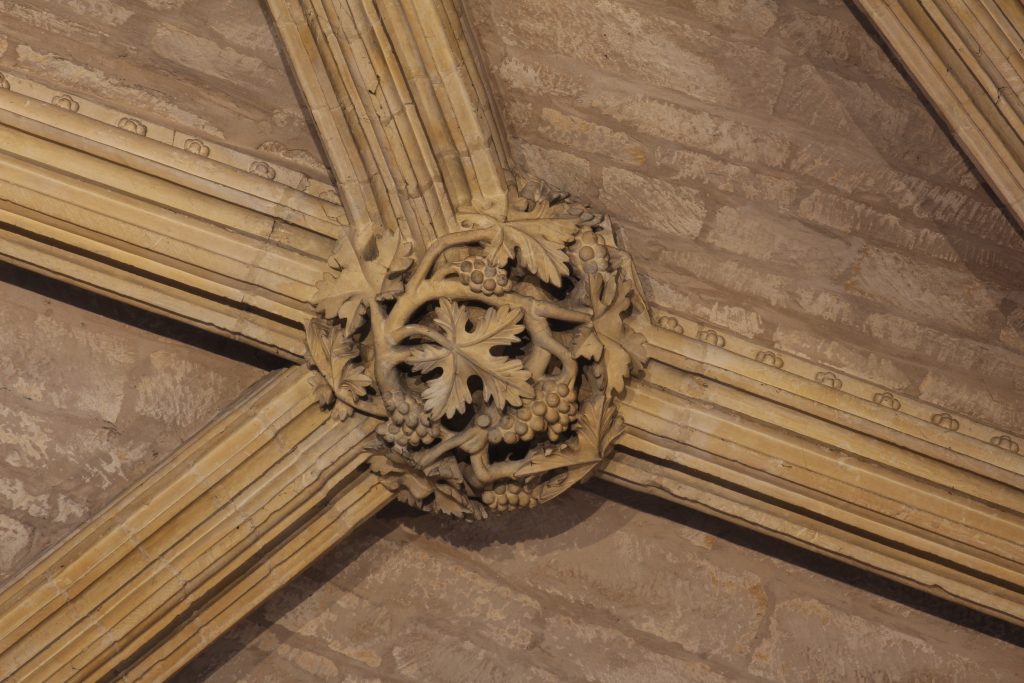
[0,368,392,681]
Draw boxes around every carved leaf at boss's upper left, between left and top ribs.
[314,232,413,336]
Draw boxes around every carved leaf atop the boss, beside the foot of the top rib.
[487,218,577,285]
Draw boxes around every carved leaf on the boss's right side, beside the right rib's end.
[572,273,647,394]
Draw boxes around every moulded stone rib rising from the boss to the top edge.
[267,0,509,248]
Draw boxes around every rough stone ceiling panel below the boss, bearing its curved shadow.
[175,489,1024,683]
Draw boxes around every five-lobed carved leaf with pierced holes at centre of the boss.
[410,299,534,420]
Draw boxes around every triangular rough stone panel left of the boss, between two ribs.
[0,266,264,584]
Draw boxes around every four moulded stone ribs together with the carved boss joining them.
[0,0,1024,681]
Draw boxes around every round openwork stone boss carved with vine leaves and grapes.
[306,183,647,519]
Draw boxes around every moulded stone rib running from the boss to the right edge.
[600,323,1024,624]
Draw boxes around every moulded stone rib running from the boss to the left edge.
[0,77,343,358]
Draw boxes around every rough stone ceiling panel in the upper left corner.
[0,0,324,176]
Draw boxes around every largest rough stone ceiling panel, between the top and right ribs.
[466,0,1024,432]
